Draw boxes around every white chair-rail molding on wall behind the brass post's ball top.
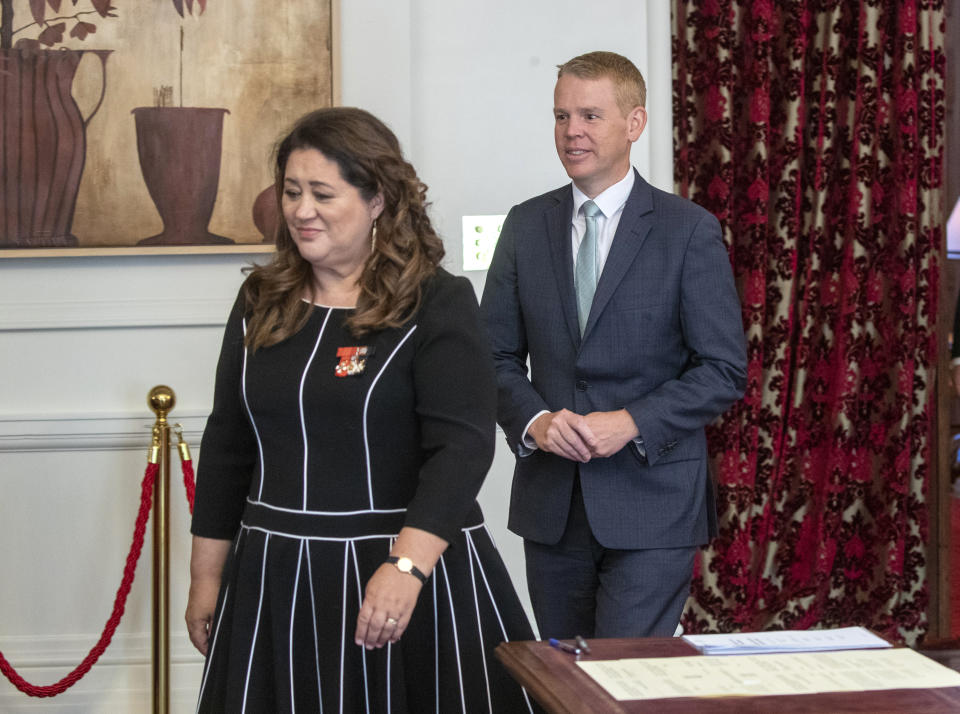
[0,409,207,453]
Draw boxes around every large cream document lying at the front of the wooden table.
[577,647,960,701]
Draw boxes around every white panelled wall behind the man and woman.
[0,0,672,712]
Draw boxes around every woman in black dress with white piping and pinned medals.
[186,108,533,714]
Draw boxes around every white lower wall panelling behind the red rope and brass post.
[0,442,202,713]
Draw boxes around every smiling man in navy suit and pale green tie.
[482,52,746,638]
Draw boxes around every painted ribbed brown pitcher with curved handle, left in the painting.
[0,49,110,248]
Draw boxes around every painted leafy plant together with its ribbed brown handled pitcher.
[0,0,212,247]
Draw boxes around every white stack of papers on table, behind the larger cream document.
[683,627,891,655]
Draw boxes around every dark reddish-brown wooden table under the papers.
[496,637,960,714]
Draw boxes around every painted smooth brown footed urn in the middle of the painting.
[133,107,234,245]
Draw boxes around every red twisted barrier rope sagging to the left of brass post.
[0,464,158,697]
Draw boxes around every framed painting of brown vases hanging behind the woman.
[0,0,336,257]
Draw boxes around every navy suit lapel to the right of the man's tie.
[580,169,654,338]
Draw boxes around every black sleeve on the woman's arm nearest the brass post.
[190,296,256,540]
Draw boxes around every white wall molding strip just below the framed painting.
[0,296,233,332]
